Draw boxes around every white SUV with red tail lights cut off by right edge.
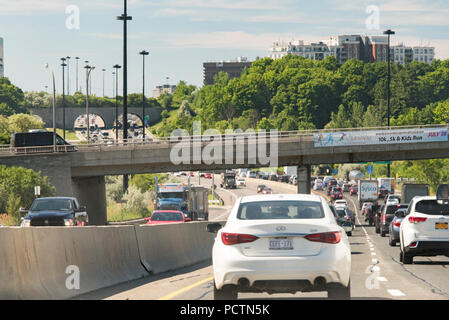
[399,196,449,264]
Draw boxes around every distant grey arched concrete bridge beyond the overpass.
[30,107,162,130]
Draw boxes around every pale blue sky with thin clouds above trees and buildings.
[0,0,449,96]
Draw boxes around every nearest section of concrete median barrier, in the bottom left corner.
[0,226,148,299]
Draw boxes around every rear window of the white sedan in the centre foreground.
[237,200,324,220]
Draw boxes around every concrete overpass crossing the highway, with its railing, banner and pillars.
[0,125,449,225]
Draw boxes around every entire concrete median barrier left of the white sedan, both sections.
[0,222,221,300]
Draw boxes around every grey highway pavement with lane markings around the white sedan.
[76,176,449,300]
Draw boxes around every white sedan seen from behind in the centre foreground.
[208,194,351,300]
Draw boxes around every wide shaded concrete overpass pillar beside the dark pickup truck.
[72,176,107,226]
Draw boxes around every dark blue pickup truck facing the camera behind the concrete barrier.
[20,197,88,227]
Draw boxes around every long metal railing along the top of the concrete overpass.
[0,124,448,156]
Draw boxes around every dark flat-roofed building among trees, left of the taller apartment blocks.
[203,57,252,85]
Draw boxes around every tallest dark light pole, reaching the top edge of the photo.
[117,0,133,192]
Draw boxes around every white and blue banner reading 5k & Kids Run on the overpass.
[313,127,448,147]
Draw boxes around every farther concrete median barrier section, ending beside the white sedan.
[135,222,224,274]
